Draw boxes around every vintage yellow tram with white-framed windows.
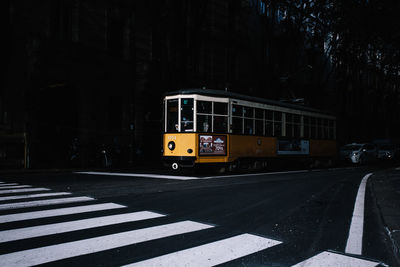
[163,89,337,170]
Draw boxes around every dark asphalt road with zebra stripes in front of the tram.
[0,166,395,266]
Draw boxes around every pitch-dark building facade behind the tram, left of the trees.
[0,0,276,168]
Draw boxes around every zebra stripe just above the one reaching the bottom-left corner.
[0,211,165,243]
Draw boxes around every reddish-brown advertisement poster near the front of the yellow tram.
[199,135,226,156]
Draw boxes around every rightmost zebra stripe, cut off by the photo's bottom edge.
[292,251,379,267]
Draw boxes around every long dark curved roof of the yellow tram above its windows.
[165,88,334,115]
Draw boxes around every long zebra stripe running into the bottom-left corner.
[0,221,213,267]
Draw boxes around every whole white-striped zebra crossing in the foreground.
[0,182,379,267]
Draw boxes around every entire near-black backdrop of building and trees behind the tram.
[0,0,400,168]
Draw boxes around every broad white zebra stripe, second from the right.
[125,234,281,267]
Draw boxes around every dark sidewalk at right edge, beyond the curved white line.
[370,167,400,264]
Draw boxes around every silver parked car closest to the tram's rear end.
[339,143,378,164]
